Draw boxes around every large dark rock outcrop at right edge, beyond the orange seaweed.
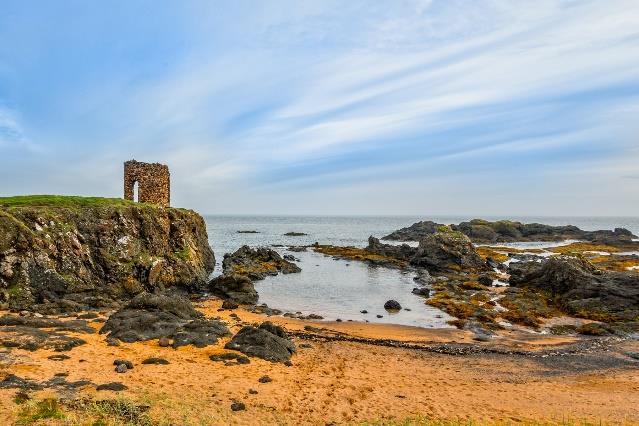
[509,256,639,321]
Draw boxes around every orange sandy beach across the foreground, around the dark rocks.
[0,301,639,425]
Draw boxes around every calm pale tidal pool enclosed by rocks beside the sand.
[255,251,452,328]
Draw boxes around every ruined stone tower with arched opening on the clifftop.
[124,160,171,207]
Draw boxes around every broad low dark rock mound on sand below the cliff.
[100,293,230,348]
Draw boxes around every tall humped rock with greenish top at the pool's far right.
[411,227,487,271]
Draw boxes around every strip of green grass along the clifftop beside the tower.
[0,195,156,208]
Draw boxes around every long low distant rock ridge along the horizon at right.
[382,219,637,245]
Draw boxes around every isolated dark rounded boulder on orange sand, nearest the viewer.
[225,321,295,362]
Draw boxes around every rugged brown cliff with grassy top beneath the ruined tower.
[0,196,215,313]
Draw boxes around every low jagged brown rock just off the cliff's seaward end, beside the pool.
[222,246,301,280]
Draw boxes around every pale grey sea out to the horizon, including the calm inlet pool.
[205,216,639,328]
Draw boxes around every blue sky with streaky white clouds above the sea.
[0,0,639,217]
